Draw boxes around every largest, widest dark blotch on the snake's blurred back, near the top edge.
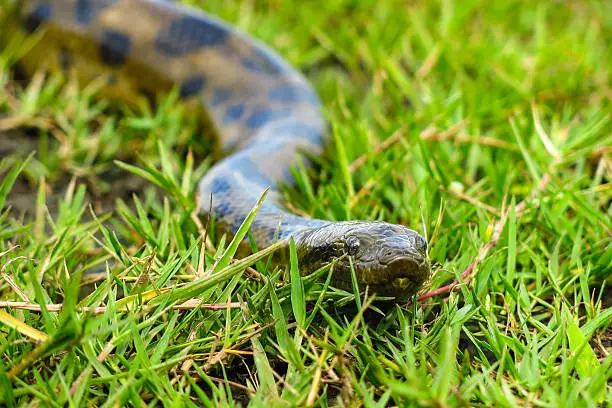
[155,16,228,57]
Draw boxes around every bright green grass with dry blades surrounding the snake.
[0,0,612,407]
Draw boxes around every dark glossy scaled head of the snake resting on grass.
[296,221,430,300]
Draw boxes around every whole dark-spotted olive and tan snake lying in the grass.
[5,0,431,301]
